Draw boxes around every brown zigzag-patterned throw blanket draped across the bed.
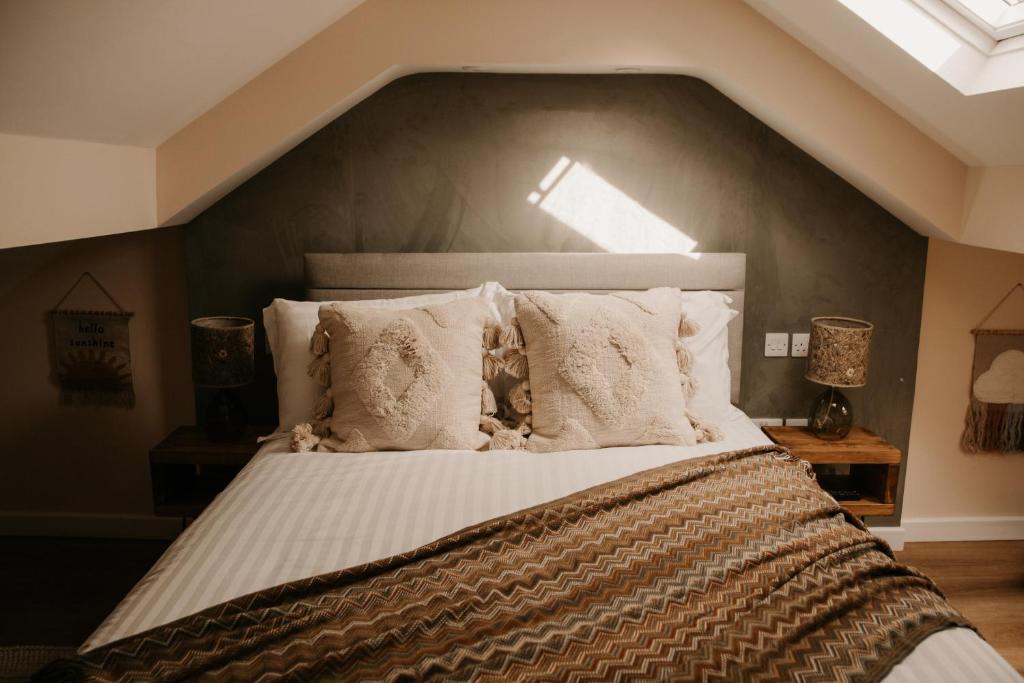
[38,446,969,681]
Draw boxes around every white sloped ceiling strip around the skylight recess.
[746,0,1024,166]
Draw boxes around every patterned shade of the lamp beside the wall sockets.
[804,316,874,387]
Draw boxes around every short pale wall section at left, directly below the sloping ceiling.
[0,133,157,249]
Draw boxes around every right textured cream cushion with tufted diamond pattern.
[515,287,696,452]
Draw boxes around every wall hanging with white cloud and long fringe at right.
[961,283,1024,453]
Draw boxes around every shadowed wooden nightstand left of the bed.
[150,426,273,518]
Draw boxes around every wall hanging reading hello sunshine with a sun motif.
[49,272,135,408]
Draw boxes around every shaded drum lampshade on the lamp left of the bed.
[191,315,255,389]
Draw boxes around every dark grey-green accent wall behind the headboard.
[186,74,927,524]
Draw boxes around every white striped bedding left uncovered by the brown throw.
[81,409,1024,683]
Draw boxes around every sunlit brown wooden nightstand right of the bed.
[763,427,903,517]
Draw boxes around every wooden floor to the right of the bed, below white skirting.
[896,541,1024,674]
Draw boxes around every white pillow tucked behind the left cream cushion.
[263,283,515,430]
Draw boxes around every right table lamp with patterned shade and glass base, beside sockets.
[804,316,874,440]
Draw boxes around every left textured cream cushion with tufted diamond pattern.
[319,298,492,452]
